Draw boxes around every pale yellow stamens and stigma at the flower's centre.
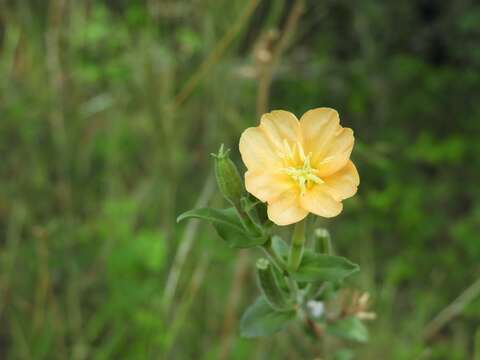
[281,141,323,195]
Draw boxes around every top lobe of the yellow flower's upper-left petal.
[260,110,300,150]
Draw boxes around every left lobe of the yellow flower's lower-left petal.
[245,170,295,202]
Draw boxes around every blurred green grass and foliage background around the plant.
[0,0,480,359]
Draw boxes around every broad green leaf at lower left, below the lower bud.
[240,296,296,338]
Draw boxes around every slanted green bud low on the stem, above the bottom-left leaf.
[256,258,288,310]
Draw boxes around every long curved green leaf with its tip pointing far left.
[177,207,267,248]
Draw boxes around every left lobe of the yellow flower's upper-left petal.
[239,127,281,171]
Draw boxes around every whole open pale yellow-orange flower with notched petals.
[240,108,360,225]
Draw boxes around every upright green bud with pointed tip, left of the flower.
[212,144,245,208]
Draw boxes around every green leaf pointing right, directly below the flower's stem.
[292,250,360,282]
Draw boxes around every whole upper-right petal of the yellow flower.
[300,108,354,178]
